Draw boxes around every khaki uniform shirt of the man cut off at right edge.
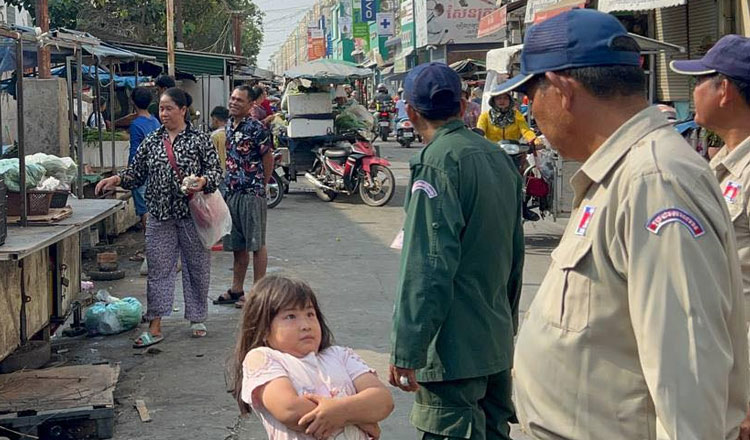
[711,138,750,319]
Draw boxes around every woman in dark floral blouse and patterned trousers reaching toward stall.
[96,88,222,348]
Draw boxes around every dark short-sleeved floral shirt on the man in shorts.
[224,116,273,197]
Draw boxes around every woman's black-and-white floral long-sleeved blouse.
[118,125,222,221]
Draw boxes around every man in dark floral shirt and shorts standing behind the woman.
[214,85,273,307]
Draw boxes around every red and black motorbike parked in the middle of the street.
[305,133,396,206]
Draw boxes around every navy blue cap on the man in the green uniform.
[404,63,461,120]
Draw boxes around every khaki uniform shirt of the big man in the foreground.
[514,108,748,440]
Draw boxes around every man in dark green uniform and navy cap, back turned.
[390,63,524,440]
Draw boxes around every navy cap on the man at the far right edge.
[669,35,750,82]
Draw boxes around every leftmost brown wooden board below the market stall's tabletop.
[0,261,21,359]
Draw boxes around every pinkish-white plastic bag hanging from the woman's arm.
[190,191,232,249]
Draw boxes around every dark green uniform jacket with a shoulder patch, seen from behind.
[391,121,524,382]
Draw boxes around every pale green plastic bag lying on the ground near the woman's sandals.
[84,297,143,335]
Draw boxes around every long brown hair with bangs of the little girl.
[230,275,333,414]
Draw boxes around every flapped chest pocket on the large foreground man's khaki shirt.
[550,238,591,332]
